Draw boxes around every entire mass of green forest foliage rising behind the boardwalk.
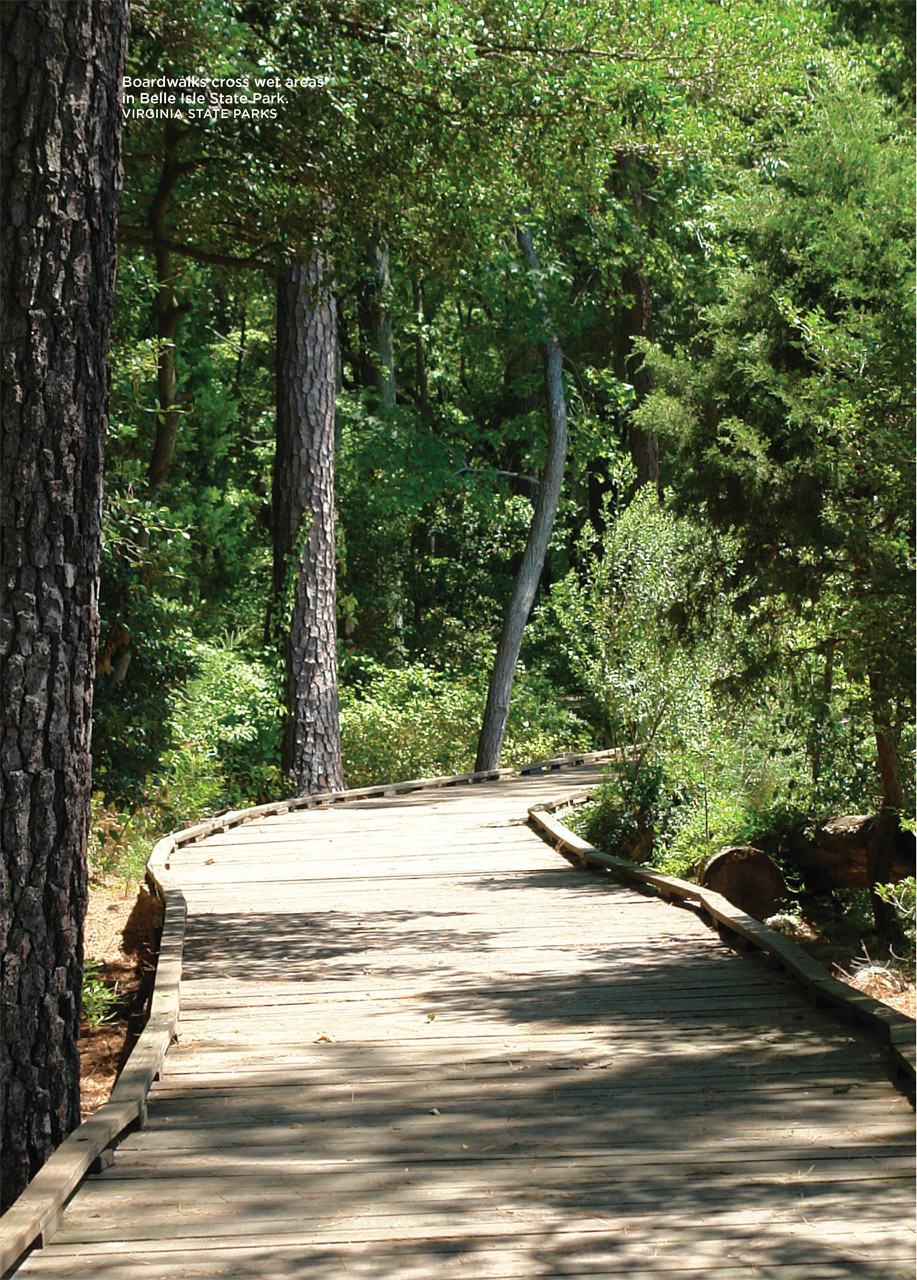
[93,0,913,860]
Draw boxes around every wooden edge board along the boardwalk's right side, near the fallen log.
[529,791,917,1091]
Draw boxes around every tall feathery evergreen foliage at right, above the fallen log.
[635,70,914,808]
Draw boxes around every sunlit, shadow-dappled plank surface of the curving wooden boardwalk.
[17,769,914,1280]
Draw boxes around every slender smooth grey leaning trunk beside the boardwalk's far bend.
[474,227,567,772]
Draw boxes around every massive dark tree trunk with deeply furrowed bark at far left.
[0,0,128,1206]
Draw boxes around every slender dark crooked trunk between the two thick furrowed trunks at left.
[147,120,195,489]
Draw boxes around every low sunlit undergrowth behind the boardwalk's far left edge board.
[90,637,593,882]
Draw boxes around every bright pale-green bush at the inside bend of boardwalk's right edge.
[543,476,870,876]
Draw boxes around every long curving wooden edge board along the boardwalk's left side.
[0,750,620,1276]
